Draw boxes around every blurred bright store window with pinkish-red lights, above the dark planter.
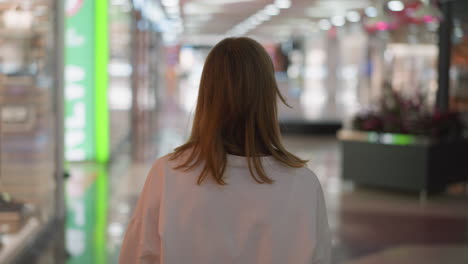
[362,2,439,109]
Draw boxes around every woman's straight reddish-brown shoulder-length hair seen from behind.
[171,37,307,185]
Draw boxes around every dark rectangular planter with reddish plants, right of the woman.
[338,84,468,194]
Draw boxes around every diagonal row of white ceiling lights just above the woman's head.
[227,0,291,35]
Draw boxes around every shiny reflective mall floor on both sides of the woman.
[66,98,468,264]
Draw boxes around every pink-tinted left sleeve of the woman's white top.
[119,164,163,264]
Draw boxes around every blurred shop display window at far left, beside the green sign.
[0,0,63,263]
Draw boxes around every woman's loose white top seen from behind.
[119,155,331,264]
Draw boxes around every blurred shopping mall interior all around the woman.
[0,0,468,264]
